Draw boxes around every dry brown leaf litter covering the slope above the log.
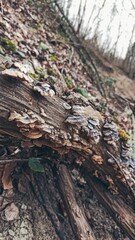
[0,0,132,240]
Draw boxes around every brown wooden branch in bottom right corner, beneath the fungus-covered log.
[85,172,135,240]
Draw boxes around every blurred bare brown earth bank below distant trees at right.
[84,40,135,101]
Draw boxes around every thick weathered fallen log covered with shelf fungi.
[0,72,135,239]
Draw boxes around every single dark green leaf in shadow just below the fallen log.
[28,158,45,172]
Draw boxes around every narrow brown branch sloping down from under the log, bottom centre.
[58,165,95,240]
